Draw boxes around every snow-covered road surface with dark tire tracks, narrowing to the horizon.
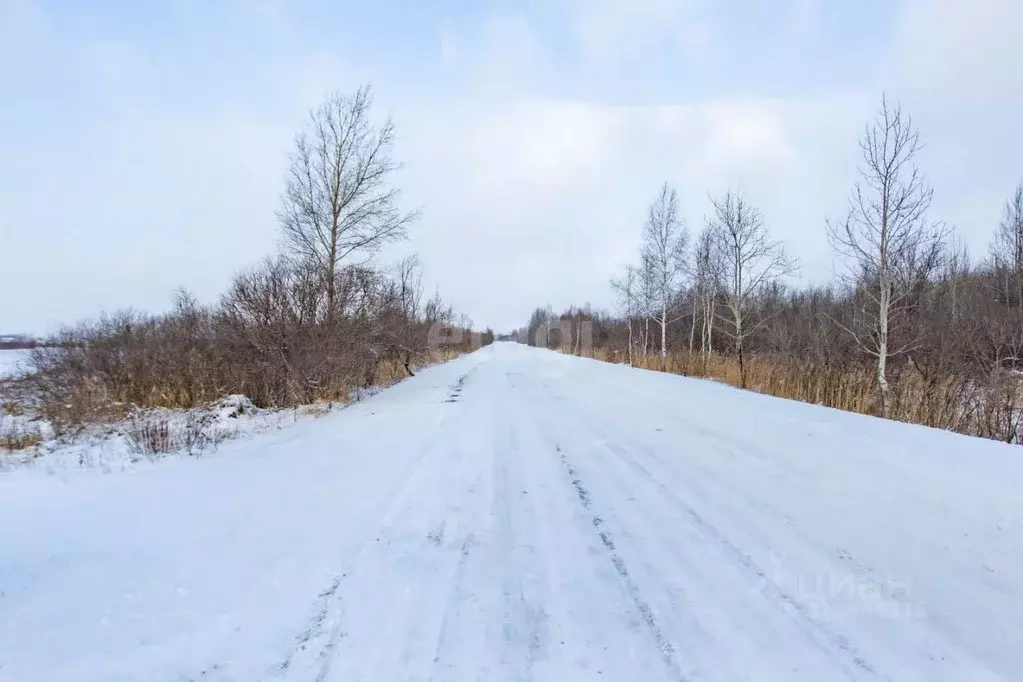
[0,344,1023,682]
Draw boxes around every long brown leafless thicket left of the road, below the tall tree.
[27,260,482,430]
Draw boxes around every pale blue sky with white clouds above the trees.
[0,0,1023,333]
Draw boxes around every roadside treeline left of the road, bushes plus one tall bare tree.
[24,87,492,422]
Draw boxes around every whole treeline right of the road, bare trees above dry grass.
[519,100,1023,443]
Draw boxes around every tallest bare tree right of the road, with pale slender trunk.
[828,97,945,417]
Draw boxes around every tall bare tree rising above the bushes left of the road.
[277,86,416,316]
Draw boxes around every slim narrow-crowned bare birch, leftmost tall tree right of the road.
[642,183,688,358]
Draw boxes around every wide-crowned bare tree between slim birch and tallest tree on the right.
[707,191,795,388]
